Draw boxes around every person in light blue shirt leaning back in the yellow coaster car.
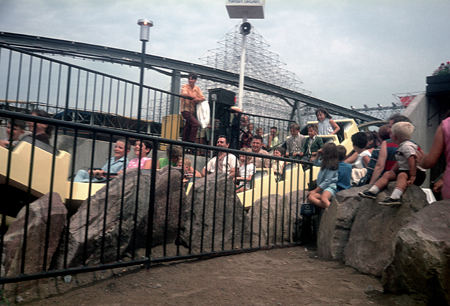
[73,139,130,183]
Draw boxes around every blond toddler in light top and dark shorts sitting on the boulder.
[358,122,425,205]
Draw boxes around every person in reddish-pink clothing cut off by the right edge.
[417,113,450,199]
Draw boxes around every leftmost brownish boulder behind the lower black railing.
[4,192,67,293]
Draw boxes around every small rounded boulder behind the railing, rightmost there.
[248,195,297,246]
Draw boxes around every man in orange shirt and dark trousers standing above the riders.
[180,72,205,142]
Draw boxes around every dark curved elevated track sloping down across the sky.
[0,32,379,122]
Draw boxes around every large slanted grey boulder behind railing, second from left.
[58,168,184,267]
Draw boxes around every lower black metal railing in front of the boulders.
[0,110,313,283]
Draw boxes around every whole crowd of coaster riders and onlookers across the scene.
[0,71,450,213]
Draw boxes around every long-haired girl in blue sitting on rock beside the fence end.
[308,142,339,209]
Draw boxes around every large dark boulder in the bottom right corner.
[382,200,450,305]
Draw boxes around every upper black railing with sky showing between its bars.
[0,45,174,134]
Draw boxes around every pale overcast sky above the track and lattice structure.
[0,0,450,107]
